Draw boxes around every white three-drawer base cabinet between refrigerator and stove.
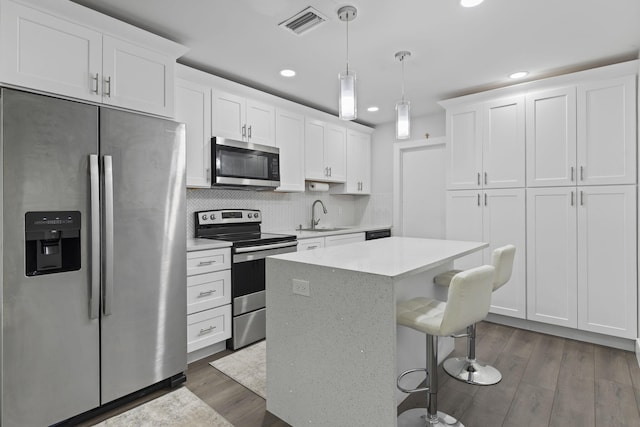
[187,248,231,356]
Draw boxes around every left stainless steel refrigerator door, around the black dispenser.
[0,89,100,427]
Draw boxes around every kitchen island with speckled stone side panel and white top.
[266,237,488,426]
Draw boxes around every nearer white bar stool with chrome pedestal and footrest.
[396,265,495,427]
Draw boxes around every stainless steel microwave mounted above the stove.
[211,136,280,190]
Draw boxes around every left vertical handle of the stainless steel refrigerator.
[89,154,100,319]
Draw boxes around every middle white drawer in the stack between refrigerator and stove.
[187,270,231,314]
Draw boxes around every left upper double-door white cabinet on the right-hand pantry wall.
[447,96,525,190]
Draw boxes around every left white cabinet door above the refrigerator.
[0,2,102,102]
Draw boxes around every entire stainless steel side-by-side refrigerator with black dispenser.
[0,89,187,427]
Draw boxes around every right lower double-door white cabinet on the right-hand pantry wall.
[527,185,637,338]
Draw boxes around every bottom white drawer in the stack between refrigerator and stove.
[187,304,231,353]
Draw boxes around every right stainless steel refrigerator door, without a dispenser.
[100,109,187,404]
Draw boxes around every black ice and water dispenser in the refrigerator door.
[25,211,80,276]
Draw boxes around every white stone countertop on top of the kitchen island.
[269,237,489,278]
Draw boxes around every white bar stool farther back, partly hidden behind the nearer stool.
[433,245,516,385]
